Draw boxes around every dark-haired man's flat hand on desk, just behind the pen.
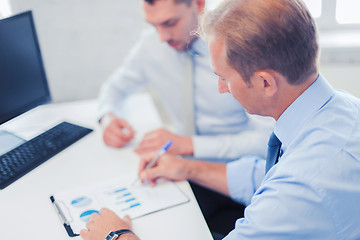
[135,129,194,155]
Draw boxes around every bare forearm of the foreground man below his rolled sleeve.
[184,160,229,195]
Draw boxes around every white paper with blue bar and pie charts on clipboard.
[50,176,189,237]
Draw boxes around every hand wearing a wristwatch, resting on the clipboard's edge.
[80,208,139,240]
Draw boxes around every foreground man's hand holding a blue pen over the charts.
[138,152,190,185]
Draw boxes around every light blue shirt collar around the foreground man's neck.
[274,74,334,150]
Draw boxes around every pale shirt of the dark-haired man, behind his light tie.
[99,30,274,161]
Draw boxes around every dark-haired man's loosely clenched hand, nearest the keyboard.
[101,114,135,148]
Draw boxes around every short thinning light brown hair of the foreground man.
[199,0,319,85]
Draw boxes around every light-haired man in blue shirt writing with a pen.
[82,0,360,240]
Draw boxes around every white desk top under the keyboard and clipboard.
[0,95,212,240]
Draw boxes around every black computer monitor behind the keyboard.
[0,11,51,124]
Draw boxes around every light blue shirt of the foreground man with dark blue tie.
[225,75,360,240]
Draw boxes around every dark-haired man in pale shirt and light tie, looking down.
[99,0,273,236]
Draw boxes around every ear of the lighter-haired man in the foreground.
[253,71,278,97]
